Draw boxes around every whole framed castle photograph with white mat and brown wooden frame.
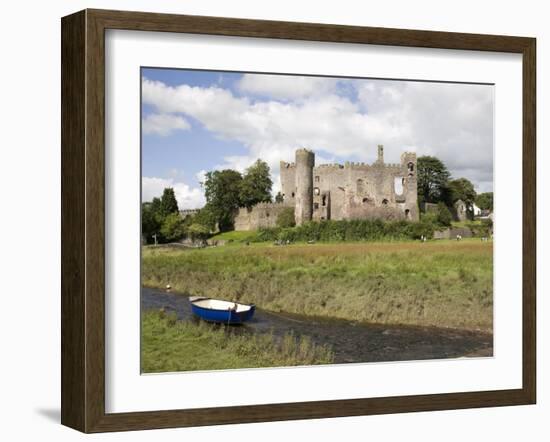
[61,10,536,432]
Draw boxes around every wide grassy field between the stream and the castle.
[142,239,493,331]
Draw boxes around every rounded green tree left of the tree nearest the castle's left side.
[204,169,243,231]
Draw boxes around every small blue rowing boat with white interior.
[189,296,256,324]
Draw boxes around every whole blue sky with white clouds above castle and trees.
[141,68,493,208]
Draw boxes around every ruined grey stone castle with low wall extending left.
[235,145,419,230]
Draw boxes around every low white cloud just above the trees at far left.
[141,177,206,209]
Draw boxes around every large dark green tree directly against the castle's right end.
[417,156,451,203]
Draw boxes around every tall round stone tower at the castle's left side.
[294,149,315,226]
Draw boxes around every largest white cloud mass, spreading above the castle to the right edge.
[143,75,493,189]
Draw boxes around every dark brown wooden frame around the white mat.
[61,10,536,432]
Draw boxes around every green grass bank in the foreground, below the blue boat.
[141,311,333,373]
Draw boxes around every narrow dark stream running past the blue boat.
[141,287,493,364]
